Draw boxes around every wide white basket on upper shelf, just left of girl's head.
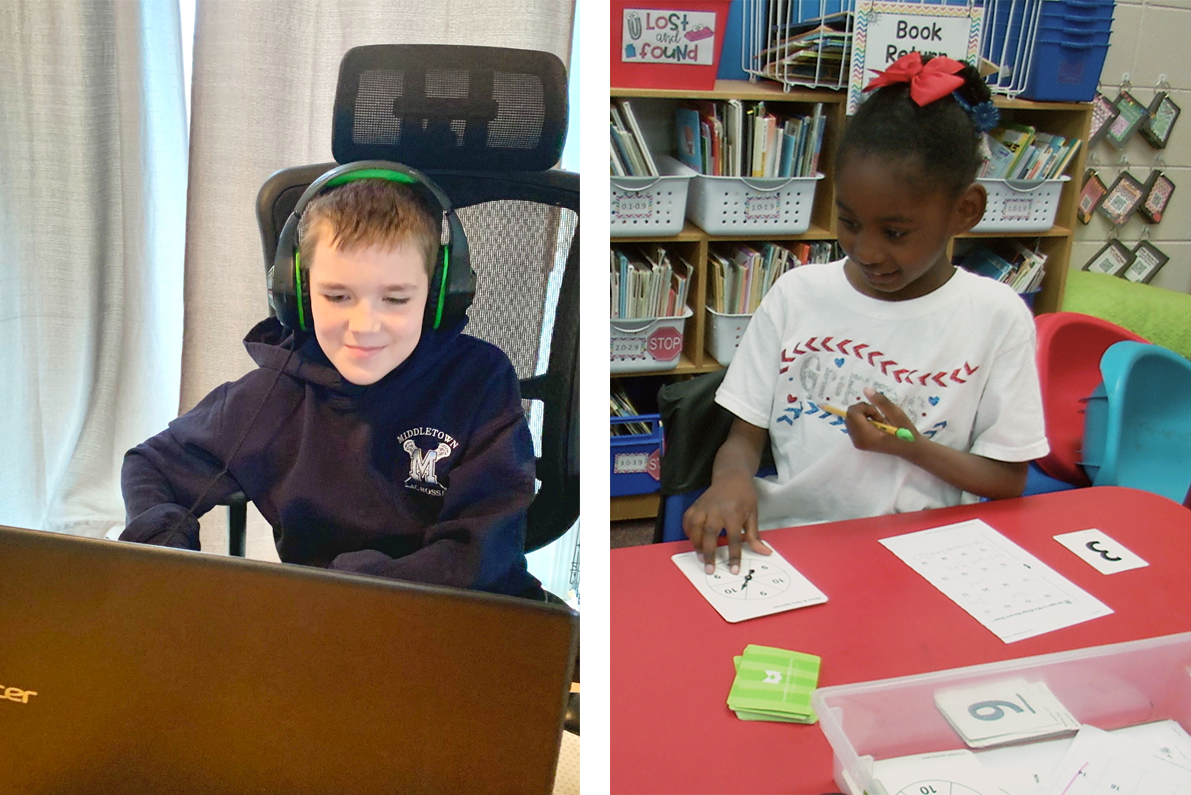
[687,174,823,234]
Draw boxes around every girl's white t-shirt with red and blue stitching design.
[716,259,1049,530]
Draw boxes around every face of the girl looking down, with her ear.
[835,151,986,301]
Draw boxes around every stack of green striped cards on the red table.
[728,644,819,724]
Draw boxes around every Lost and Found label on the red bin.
[621,8,716,67]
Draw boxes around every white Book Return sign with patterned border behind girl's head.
[848,0,984,115]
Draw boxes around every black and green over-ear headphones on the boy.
[269,161,475,331]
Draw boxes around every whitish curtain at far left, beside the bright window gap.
[0,0,187,536]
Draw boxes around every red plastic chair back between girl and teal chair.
[1034,312,1146,486]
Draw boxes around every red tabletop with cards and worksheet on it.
[610,487,1191,795]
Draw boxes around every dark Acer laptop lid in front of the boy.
[0,527,579,795]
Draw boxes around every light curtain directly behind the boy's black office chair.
[180,0,574,593]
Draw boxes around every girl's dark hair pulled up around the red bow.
[836,56,992,195]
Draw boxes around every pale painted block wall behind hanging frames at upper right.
[1071,0,1191,293]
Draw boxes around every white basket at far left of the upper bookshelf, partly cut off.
[609,155,694,237]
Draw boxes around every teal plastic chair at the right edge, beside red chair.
[1083,342,1191,502]
